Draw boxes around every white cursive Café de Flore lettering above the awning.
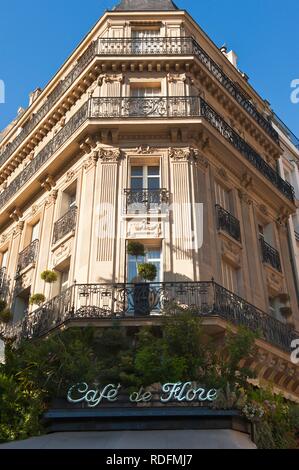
[67,382,217,408]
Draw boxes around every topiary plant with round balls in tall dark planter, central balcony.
[127,242,157,316]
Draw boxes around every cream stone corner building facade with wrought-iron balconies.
[0,0,299,400]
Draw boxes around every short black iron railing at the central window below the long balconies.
[124,189,169,214]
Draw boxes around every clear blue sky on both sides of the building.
[0,0,299,136]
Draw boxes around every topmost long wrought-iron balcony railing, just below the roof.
[0,37,279,173]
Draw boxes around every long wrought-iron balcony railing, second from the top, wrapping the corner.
[0,96,295,212]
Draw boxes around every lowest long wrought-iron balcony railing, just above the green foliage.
[0,281,298,351]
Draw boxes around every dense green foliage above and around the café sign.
[0,305,299,448]
